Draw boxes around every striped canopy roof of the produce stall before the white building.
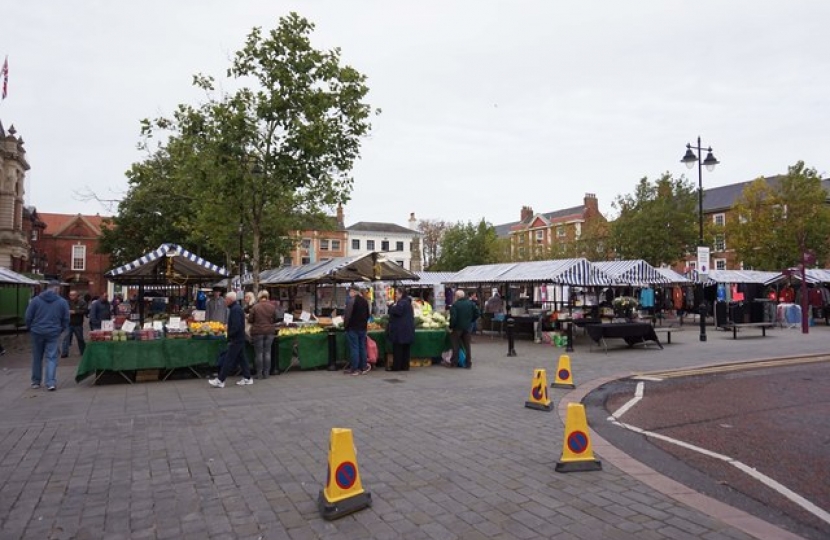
[260,252,418,285]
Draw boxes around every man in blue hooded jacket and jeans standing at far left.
[26,281,69,391]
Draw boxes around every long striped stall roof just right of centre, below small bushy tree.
[451,258,614,287]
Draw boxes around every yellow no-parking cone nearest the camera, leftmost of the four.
[317,428,372,520]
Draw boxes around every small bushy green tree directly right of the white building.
[434,219,500,272]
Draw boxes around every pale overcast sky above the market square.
[0,0,830,226]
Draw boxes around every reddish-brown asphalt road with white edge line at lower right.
[585,361,830,540]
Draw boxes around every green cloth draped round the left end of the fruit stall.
[75,339,227,382]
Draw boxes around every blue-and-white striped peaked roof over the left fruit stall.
[104,244,228,285]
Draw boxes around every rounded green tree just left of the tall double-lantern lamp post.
[609,173,698,266]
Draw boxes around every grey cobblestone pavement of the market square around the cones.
[0,327,830,540]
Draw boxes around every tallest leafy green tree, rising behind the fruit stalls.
[115,13,379,289]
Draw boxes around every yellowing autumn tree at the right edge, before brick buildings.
[726,161,830,270]
